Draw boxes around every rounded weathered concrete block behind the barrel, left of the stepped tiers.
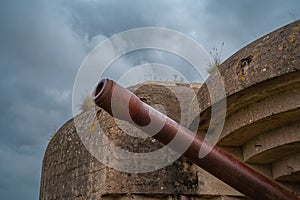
[40,83,243,200]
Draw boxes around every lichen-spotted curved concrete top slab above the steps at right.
[198,21,300,130]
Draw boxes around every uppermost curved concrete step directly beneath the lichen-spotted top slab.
[219,88,300,146]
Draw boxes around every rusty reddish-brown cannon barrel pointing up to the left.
[94,79,299,200]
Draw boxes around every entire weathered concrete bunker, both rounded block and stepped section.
[40,21,300,200]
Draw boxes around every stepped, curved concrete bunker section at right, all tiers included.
[197,21,300,194]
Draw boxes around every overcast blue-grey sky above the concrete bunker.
[0,0,300,200]
